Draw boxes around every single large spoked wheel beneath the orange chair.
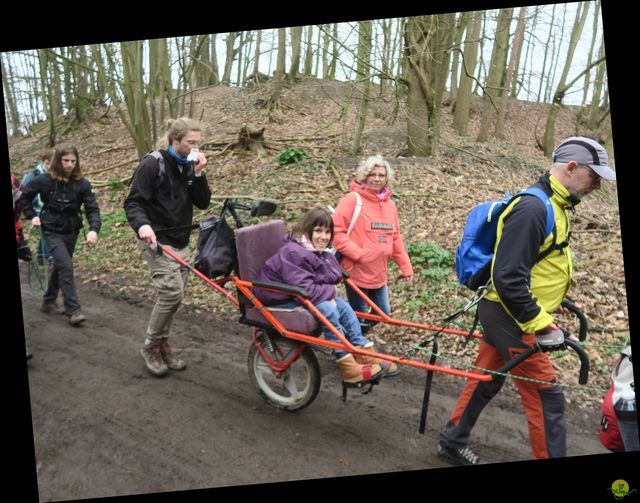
[247,330,321,412]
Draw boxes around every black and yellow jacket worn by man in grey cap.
[486,173,578,333]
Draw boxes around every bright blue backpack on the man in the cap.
[456,187,566,290]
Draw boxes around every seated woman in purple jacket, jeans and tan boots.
[256,208,398,386]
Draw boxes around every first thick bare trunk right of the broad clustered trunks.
[453,11,484,136]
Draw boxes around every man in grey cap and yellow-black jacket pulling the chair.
[438,137,616,465]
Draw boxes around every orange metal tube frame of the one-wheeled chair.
[161,247,493,381]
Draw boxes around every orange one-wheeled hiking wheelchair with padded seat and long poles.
[158,199,589,432]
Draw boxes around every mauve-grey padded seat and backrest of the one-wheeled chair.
[236,220,320,335]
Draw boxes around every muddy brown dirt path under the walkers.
[22,266,605,501]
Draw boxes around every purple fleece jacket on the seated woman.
[255,236,342,305]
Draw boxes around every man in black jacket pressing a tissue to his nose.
[124,117,211,376]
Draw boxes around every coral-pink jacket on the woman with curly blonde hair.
[333,180,413,288]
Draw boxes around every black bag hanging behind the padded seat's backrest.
[194,216,237,279]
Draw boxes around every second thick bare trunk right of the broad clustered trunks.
[477,7,513,142]
